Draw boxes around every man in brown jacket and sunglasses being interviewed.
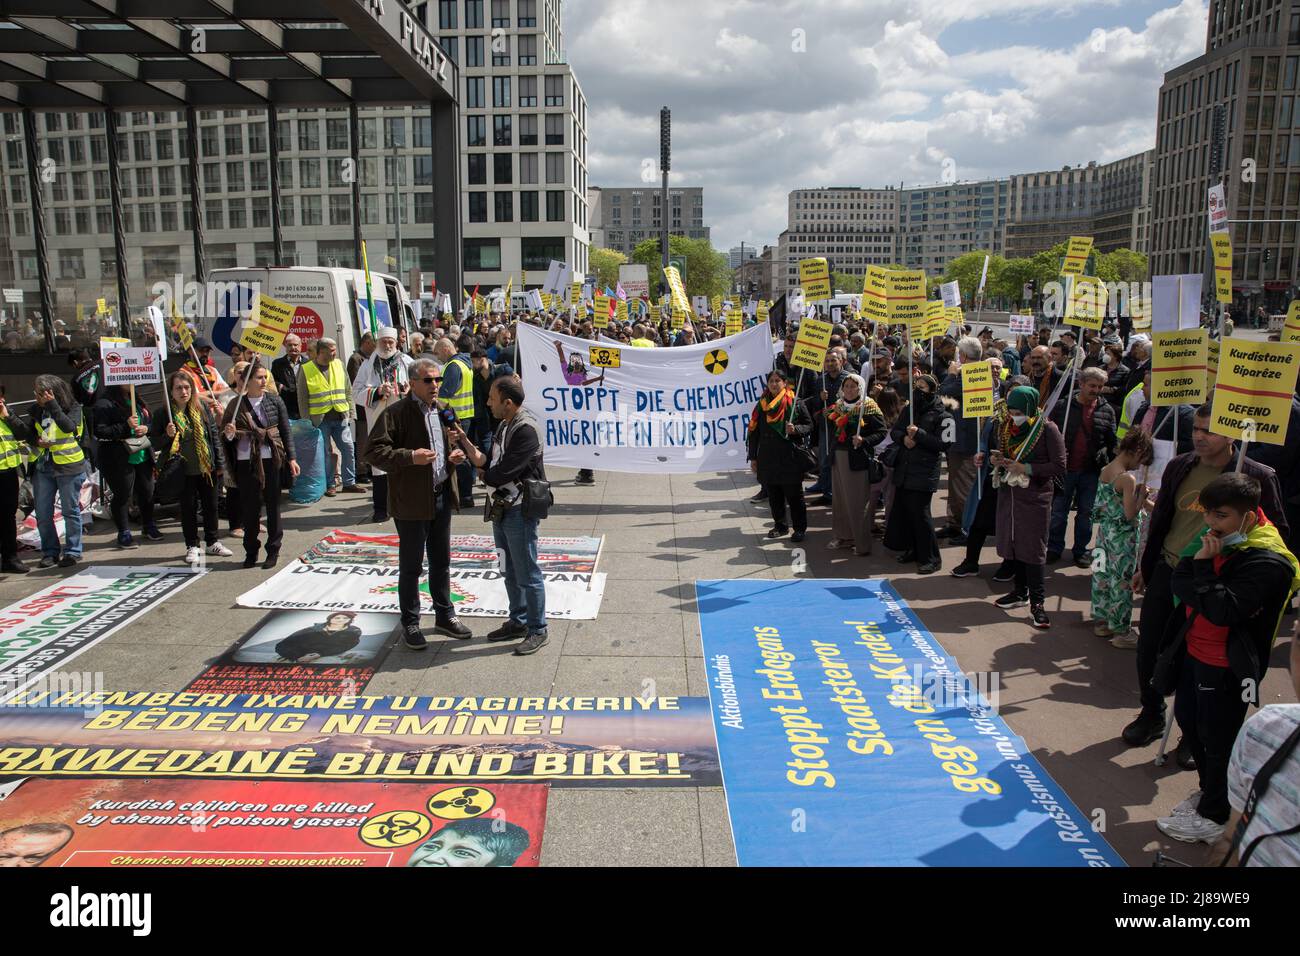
[365,359,473,650]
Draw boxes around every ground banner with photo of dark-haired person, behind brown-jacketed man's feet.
[185,611,398,693]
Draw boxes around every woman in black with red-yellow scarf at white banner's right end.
[748,368,813,544]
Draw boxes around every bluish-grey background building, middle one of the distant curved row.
[896,179,1009,277]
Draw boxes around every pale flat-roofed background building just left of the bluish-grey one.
[772,186,898,295]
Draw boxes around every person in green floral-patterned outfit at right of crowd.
[1092,428,1156,648]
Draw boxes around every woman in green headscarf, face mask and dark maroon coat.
[975,385,1065,631]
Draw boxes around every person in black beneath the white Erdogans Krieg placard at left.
[95,385,163,549]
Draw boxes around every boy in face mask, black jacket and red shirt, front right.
[1154,473,1300,844]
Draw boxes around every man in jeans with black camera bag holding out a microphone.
[452,375,551,656]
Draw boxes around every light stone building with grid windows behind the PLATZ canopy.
[0,0,589,345]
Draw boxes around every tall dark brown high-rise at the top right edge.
[1152,0,1300,310]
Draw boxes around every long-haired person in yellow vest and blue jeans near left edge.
[27,375,86,567]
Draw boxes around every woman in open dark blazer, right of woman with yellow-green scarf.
[221,365,298,568]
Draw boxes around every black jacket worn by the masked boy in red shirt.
[1152,548,1292,695]
